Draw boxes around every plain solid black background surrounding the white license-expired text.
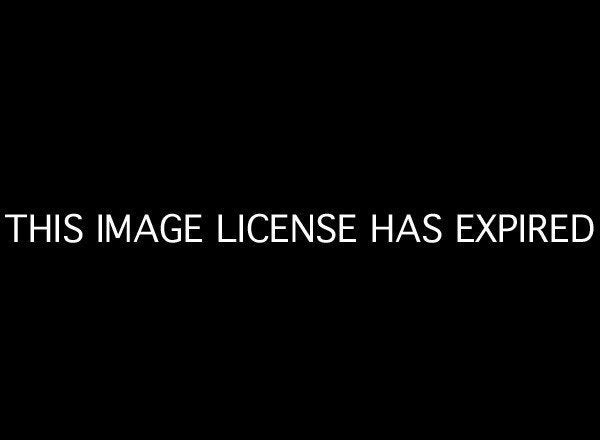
[1,5,598,433]
